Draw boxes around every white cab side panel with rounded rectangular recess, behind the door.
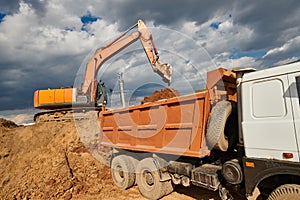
[242,75,300,161]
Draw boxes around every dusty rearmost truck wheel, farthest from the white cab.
[110,155,135,190]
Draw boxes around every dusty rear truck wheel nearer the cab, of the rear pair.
[136,158,173,199]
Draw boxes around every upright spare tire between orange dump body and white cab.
[206,101,236,151]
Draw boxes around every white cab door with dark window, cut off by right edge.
[288,72,300,159]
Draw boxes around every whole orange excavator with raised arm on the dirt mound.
[34,20,172,122]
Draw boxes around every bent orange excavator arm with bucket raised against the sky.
[81,20,172,102]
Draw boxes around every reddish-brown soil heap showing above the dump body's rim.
[141,88,179,104]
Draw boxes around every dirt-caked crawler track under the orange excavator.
[33,107,101,123]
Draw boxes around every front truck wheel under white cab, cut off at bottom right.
[268,184,300,200]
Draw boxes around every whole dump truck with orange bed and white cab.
[99,62,300,200]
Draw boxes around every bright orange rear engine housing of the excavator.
[34,88,74,109]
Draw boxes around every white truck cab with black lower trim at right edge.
[240,62,300,199]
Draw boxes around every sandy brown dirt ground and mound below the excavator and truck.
[0,119,244,200]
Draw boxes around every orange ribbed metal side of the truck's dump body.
[100,91,210,157]
